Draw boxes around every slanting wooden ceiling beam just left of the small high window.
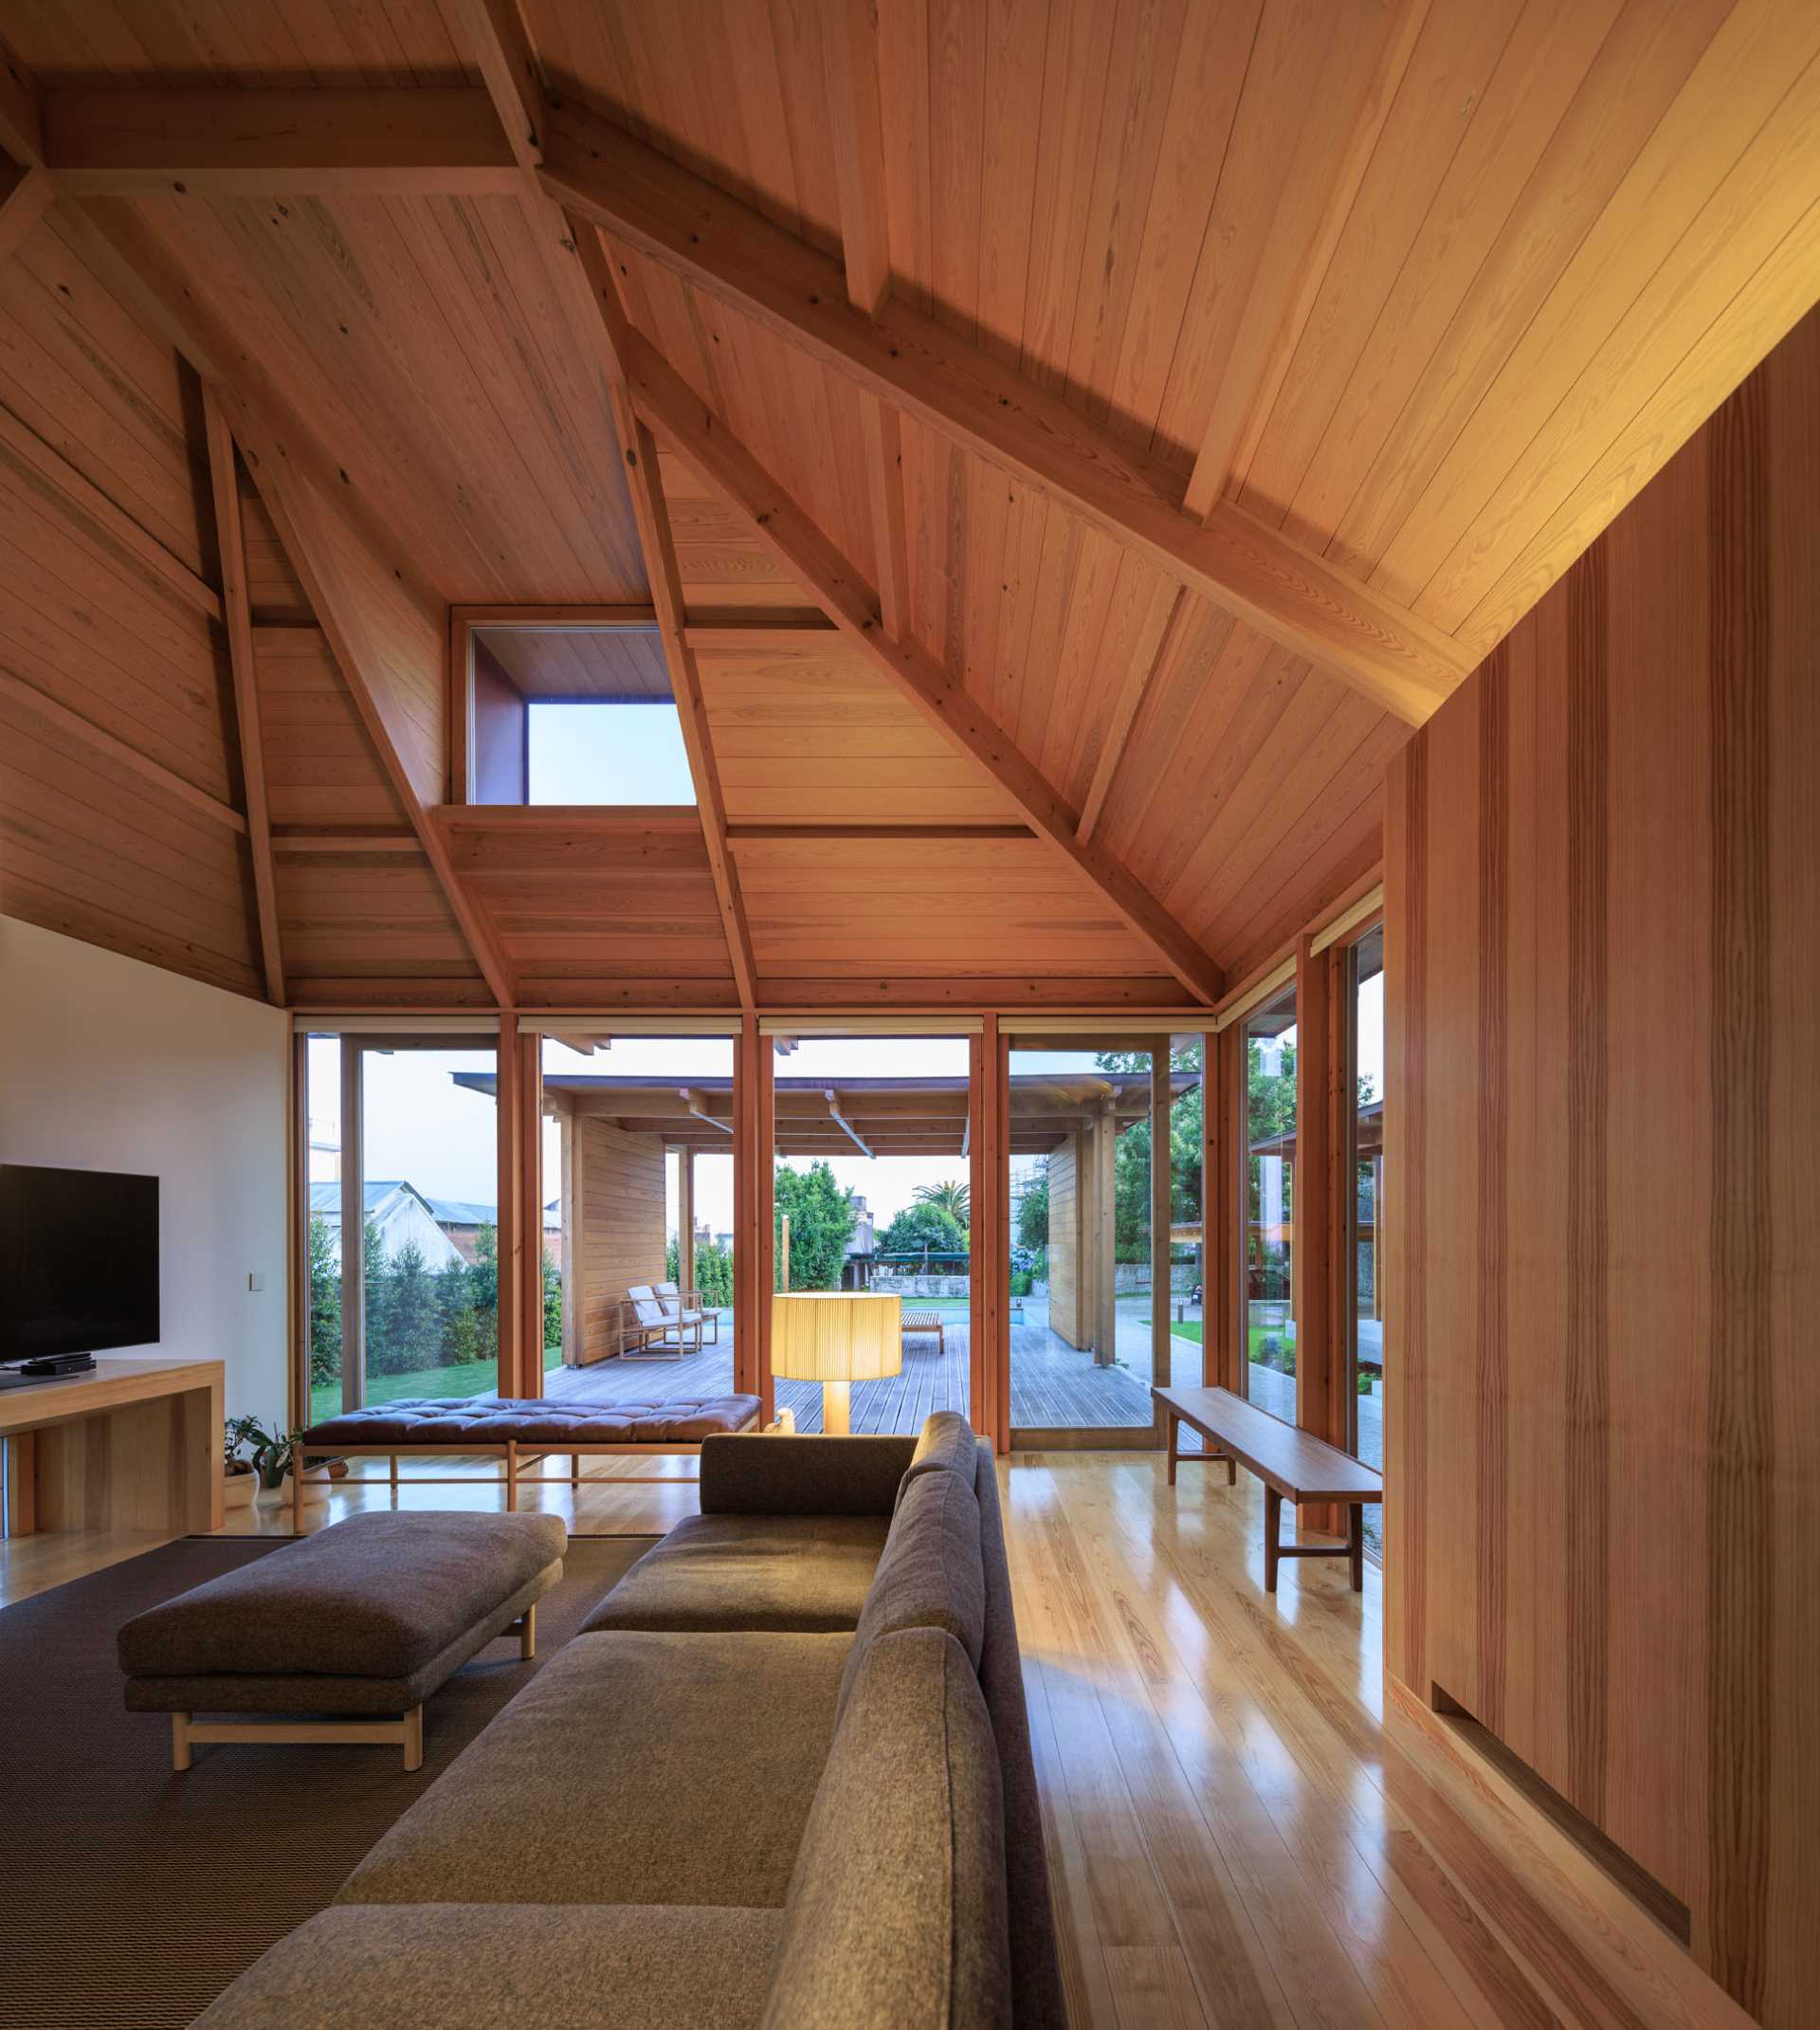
[237,434,516,1009]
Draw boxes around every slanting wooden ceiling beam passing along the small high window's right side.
[568,208,759,1009]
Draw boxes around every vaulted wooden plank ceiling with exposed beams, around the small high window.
[0,0,1820,1007]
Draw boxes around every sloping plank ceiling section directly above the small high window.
[88,195,647,603]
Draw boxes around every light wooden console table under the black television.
[0,1354,223,1537]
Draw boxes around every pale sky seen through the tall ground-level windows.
[308,973,1384,1234]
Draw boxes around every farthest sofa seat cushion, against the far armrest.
[582,1509,891,1635]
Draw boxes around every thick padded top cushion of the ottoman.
[118,1510,568,1681]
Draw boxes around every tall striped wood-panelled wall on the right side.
[1386,296,1820,2024]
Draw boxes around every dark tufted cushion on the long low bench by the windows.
[304,1395,759,1452]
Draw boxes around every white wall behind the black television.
[0,918,290,1417]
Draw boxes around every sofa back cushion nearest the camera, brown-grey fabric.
[763,1628,1010,2030]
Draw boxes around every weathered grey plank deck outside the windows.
[544,1308,1176,1431]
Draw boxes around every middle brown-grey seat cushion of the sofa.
[338,1632,852,1909]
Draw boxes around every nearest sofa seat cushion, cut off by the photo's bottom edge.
[194,1904,783,2030]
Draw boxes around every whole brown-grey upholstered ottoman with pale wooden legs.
[118,1510,568,1770]
